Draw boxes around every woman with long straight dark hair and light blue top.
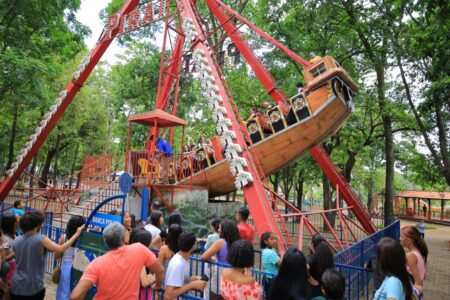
[374,238,412,300]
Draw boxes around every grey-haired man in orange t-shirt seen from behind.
[70,223,164,300]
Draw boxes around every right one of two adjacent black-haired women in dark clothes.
[306,234,334,299]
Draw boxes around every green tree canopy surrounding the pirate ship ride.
[0,0,450,215]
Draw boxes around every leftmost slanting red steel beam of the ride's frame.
[0,0,139,202]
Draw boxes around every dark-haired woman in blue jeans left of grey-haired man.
[55,216,84,300]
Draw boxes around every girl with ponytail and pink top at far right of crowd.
[400,226,428,286]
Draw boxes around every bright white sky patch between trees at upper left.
[76,0,125,64]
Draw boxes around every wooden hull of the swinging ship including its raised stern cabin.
[179,57,356,197]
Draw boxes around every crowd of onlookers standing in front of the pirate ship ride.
[0,201,428,300]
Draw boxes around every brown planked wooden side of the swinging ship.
[180,84,350,197]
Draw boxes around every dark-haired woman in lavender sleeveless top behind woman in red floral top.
[202,220,241,299]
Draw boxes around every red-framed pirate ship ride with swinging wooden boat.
[0,0,376,248]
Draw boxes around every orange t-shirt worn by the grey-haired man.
[80,243,156,300]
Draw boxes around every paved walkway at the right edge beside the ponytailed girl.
[401,220,450,300]
